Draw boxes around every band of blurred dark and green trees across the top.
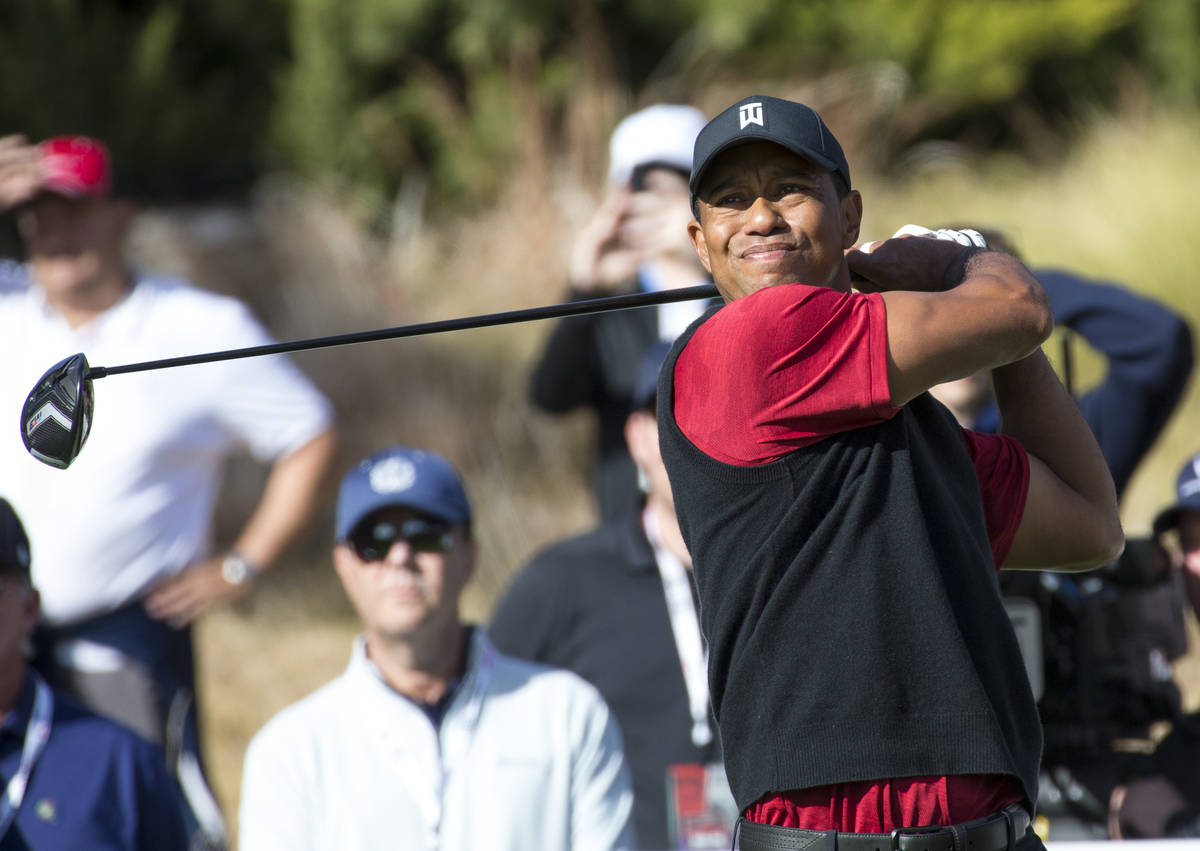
[0,0,1200,209]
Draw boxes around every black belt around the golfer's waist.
[733,804,1030,851]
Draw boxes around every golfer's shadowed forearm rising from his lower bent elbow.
[992,349,1121,539]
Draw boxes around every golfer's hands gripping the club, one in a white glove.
[846,224,988,293]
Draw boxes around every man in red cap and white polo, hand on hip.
[0,137,335,843]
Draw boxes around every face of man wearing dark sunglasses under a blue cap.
[334,508,475,637]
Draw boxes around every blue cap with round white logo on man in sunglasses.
[334,447,470,541]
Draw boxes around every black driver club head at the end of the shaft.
[20,354,94,469]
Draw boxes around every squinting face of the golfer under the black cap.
[689,142,862,300]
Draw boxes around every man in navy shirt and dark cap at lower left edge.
[0,499,187,851]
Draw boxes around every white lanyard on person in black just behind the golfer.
[642,505,713,748]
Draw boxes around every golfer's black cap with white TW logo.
[688,95,851,215]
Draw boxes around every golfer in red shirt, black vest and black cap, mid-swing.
[659,96,1123,851]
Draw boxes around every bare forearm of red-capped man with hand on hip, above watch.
[233,427,337,569]
